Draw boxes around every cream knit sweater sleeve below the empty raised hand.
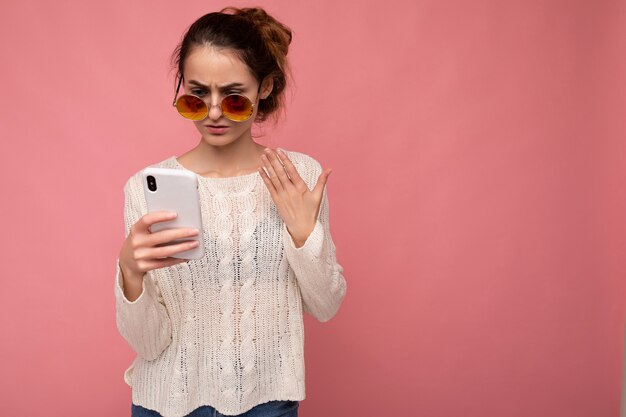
[283,164,346,322]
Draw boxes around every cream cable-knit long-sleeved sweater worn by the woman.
[115,148,346,417]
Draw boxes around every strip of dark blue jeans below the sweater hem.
[131,401,300,417]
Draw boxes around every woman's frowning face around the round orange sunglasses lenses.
[183,47,269,146]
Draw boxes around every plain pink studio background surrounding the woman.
[0,0,626,417]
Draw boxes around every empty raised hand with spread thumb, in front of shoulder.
[259,148,331,248]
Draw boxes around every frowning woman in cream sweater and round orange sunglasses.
[115,8,346,417]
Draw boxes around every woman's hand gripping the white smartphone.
[119,211,199,290]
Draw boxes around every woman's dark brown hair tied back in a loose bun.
[172,7,291,122]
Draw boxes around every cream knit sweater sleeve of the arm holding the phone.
[115,178,172,360]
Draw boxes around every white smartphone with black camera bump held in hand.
[142,167,204,259]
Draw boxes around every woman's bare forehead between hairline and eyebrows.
[184,47,255,87]
